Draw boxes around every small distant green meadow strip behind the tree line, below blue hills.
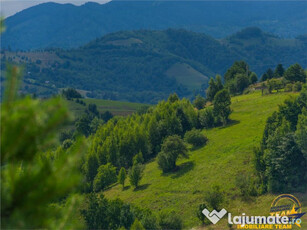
[67,98,146,116]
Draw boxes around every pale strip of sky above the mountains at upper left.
[0,0,108,17]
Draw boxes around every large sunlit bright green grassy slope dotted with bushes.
[104,92,307,229]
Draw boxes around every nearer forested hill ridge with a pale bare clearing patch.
[2,27,307,103]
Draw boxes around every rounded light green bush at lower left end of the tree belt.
[94,163,117,192]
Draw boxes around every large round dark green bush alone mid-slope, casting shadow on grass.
[157,135,187,172]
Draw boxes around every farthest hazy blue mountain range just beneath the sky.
[1,0,307,50]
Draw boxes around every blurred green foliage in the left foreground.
[1,66,85,229]
